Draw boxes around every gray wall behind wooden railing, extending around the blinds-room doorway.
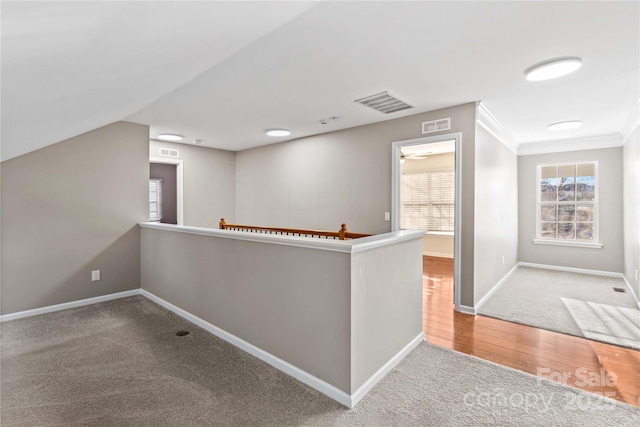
[236,103,476,306]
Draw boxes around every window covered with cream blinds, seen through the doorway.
[400,171,455,232]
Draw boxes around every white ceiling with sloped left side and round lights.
[0,1,640,160]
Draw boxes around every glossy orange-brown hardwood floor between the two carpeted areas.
[422,256,640,407]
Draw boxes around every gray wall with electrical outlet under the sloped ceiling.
[1,122,149,314]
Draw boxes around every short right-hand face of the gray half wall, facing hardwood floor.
[351,239,422,392]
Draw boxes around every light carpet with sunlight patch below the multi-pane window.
[479,267,640,350]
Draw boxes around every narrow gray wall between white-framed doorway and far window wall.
[474,126,518,305]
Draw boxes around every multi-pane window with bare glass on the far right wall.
[534,162,598,244]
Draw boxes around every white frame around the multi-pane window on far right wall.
[533,161,603,249]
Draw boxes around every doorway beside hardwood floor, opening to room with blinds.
[391,132,461,311]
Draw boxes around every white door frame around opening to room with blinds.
[391,132,462,311]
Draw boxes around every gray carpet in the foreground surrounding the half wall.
[0,297,640,427]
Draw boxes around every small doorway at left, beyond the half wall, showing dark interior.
[149,158,183,225]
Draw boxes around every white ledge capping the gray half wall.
[139,222,425,253]
